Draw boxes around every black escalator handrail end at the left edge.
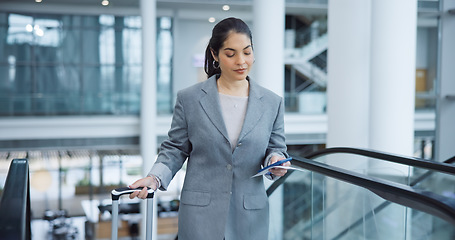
[0,159,31,240]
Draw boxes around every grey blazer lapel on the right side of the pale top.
[238,80,264,142]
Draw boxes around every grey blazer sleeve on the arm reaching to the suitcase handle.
[148,93,191,191]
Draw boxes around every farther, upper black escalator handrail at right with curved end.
[303,147,455,175]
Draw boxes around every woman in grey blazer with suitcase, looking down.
[130,18,290,240]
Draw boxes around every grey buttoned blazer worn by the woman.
[150,76,288,240]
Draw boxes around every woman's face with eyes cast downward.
[214,32,254,81]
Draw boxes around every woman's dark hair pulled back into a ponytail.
[204,17,253,77]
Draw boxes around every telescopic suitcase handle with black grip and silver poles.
[111,187,155,240]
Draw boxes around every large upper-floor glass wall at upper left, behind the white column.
[0,11,166,116]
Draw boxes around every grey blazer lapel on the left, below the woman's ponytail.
[199,76,229,141]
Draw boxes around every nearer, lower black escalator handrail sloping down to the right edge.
[292,157,455,225]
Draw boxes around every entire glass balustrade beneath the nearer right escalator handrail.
[269,167,455,240]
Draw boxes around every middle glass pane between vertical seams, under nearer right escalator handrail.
[320,174,406,240]
